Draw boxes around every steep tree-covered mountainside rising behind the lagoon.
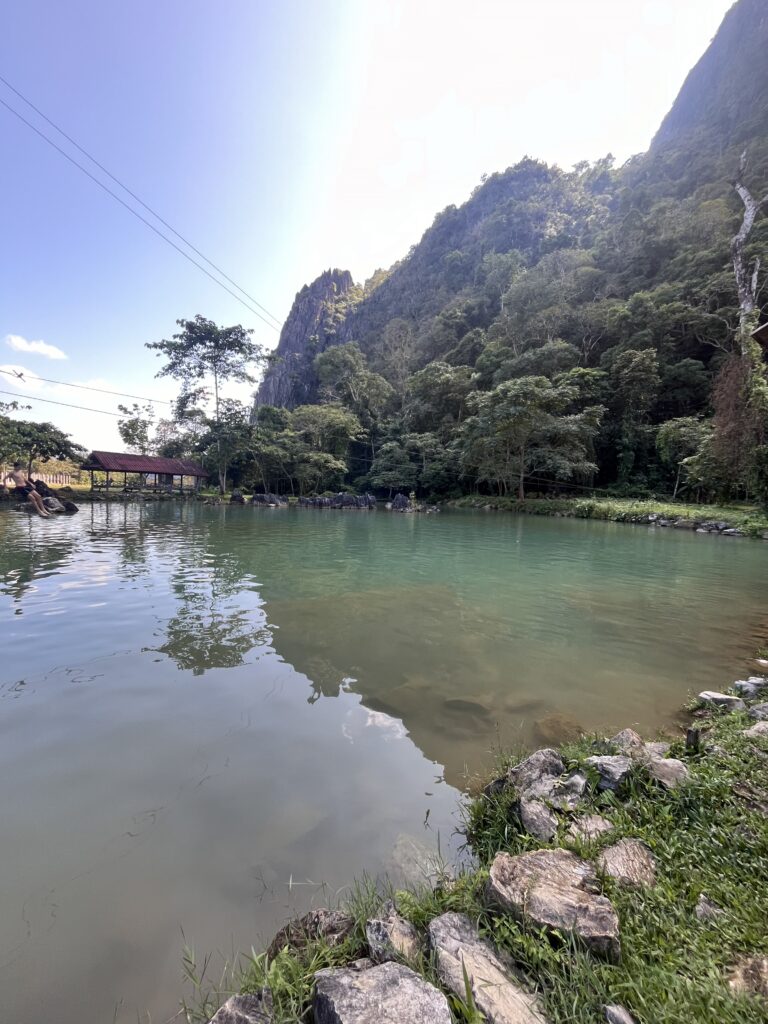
[252,0,768,498]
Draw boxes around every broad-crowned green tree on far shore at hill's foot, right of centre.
[462,377,602,500]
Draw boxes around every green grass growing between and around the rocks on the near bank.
[187,712,768,1024]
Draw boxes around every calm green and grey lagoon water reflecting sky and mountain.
[0,503,768,1024]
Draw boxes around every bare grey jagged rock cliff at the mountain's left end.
[256,269,357,409]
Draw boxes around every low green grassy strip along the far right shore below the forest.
[450,496,768,541]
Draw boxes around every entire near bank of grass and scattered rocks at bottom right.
[187,662,768,1024]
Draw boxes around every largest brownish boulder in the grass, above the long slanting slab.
[486,850,621,963]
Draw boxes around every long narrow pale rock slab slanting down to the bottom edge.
[427,913,545,1024]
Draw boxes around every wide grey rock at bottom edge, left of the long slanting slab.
[312,964,452,1024]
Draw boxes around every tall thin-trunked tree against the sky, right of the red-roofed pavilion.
[146,314,263,494]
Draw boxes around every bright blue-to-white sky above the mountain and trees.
[0,0,730,449]
